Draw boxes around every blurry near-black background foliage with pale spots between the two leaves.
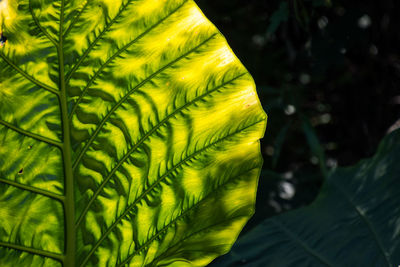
[196,0,400,239]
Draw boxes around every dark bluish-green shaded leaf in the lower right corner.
[216,130,400,267]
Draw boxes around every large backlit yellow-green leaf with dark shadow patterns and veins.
[0,0,266,266]
